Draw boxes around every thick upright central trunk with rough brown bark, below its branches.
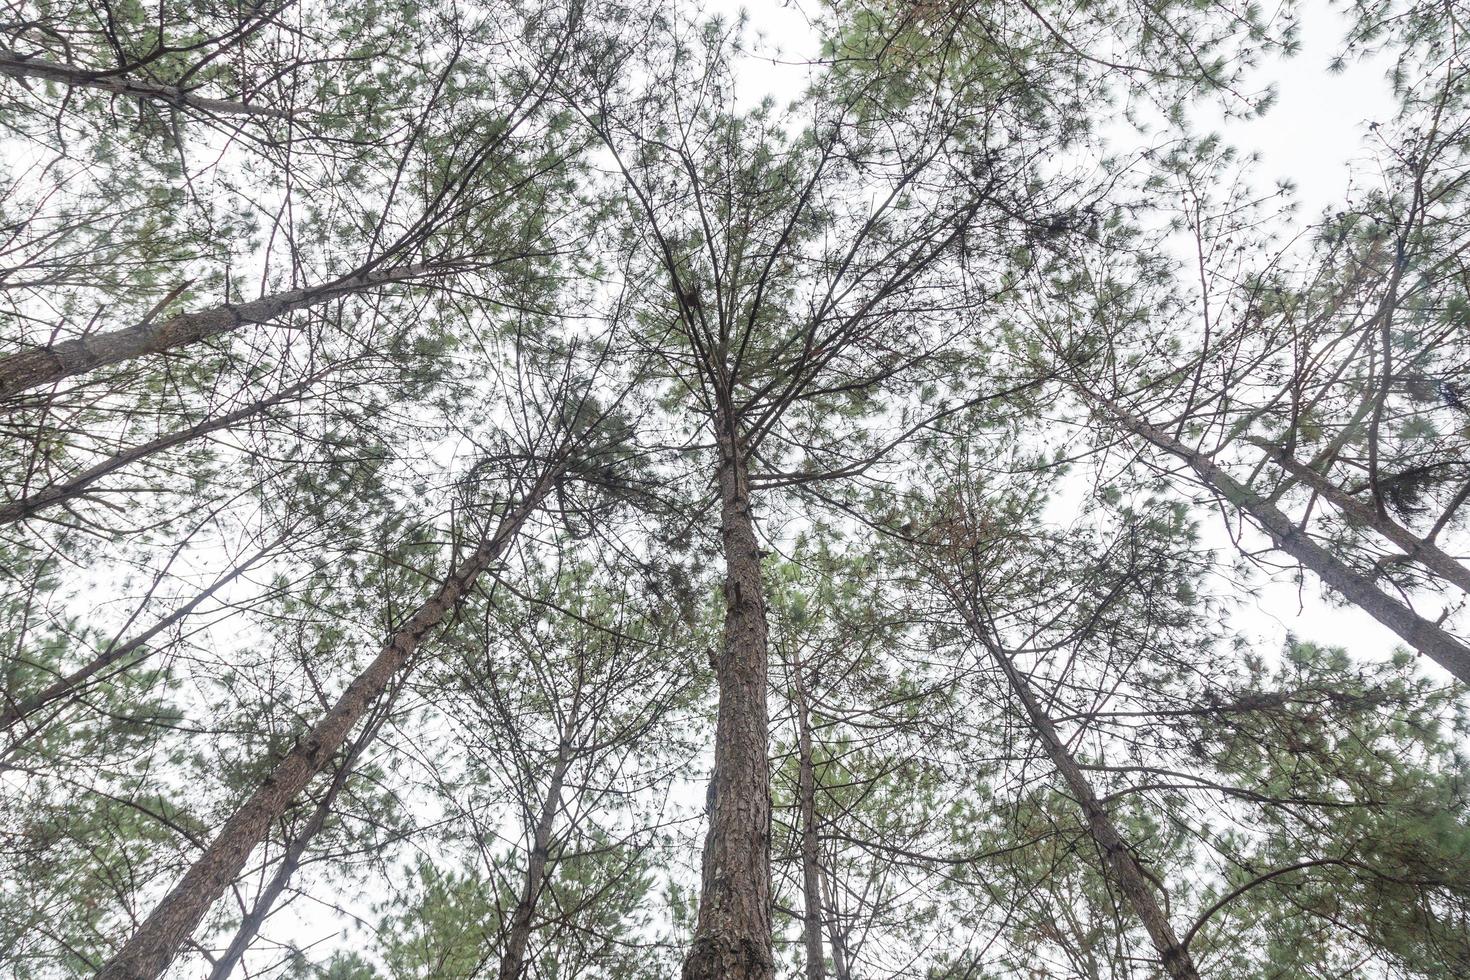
[684,431,775,980]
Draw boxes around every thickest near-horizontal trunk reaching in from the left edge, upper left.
[0,266,442,398]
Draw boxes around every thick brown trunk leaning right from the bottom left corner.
[97,466,560,980]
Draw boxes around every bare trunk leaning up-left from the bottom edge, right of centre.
[950,599,1200,980]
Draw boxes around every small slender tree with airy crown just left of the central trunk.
[431,552,700,980]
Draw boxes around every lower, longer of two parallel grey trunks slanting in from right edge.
[1082,391,1470,683]
